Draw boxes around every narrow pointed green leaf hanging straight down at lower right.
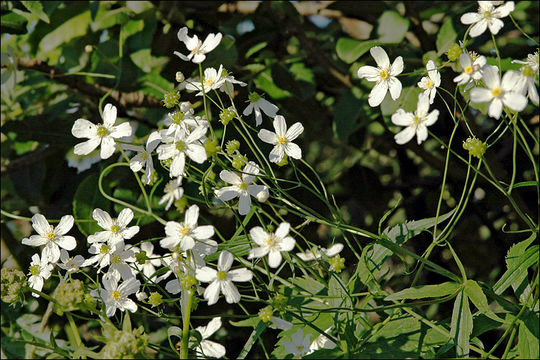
[450,291,473,358]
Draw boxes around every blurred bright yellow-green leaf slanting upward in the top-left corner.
[39,11,90,52]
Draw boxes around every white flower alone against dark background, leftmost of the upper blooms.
[71,104,133,159]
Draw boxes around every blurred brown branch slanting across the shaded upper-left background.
[11,58,163,108]
